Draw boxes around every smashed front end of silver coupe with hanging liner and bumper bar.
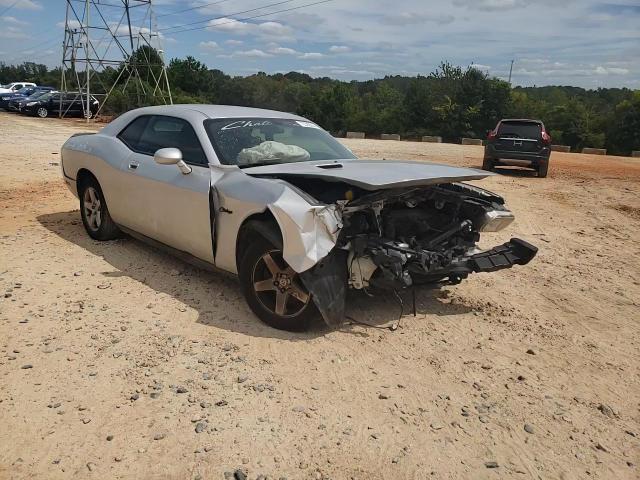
[301,183,537,326]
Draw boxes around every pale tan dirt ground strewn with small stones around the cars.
[0,113,640,480]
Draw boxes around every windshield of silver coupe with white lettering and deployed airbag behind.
[204,118,356,167]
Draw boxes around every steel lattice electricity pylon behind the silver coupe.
[60,0,173,120]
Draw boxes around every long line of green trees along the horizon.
[0,52,640,155]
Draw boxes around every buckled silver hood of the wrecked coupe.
[243,160,494,190]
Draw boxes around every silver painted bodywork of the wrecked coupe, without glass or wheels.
[62,105,489,273]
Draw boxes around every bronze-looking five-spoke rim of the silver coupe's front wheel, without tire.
[251,250,311,317]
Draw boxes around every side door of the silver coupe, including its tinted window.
[118,115,213,263]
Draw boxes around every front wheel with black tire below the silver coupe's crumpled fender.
[238,232,317,332]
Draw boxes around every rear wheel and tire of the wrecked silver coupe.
[78,177,121,241]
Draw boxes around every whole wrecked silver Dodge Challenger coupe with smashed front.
[61,105,537,330]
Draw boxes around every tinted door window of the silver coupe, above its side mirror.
[138,115,208,165]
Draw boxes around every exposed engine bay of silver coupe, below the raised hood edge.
[338,183,535,289]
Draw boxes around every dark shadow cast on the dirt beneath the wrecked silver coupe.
[38,210,469,341]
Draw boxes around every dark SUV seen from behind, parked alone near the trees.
[482,119,551,177]
